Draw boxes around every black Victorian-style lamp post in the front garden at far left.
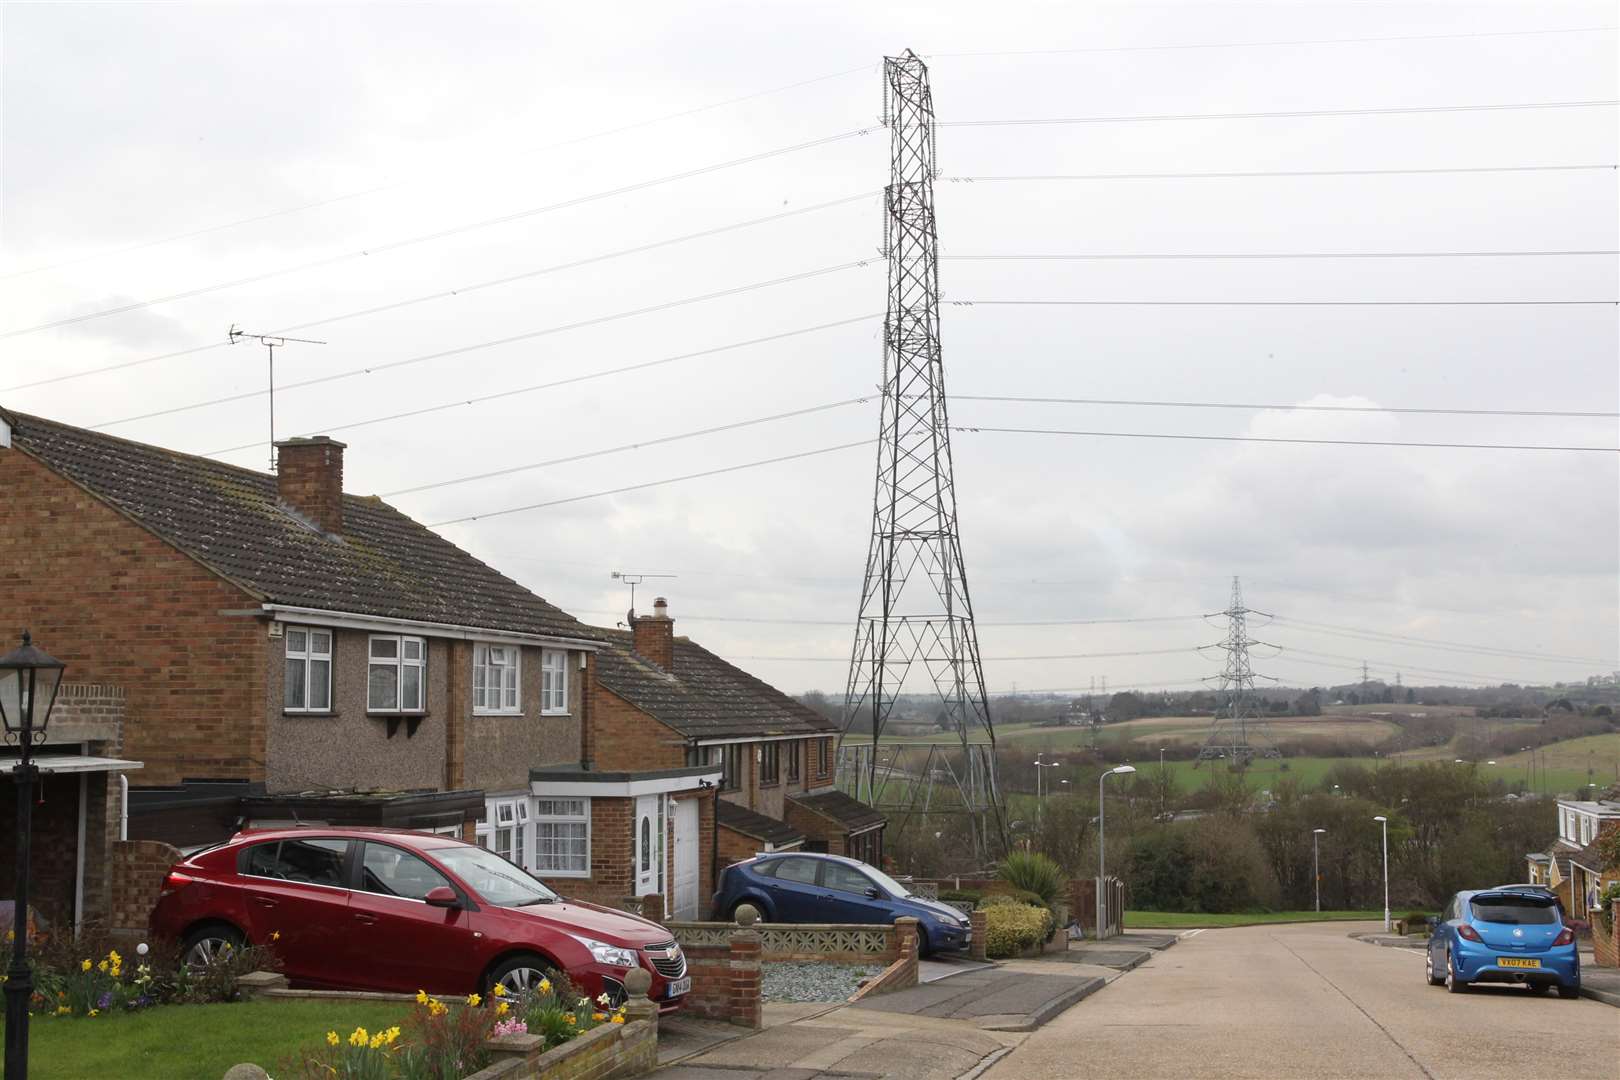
[0,630,66,1080]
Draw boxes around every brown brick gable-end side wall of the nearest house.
[0,449,266,785]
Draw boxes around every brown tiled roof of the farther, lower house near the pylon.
[591,627,838,738]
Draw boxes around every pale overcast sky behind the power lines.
[0,2,1620,702]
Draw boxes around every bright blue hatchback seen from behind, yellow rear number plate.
[1424,887,1581,997]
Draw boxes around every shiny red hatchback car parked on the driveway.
[152,827,692,1012]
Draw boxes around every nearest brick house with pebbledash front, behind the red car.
[0,411,599,906]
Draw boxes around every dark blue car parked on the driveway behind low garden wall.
[714,852,972,955]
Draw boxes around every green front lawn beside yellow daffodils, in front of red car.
[15,1001,410,1080]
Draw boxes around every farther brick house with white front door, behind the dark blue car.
[567,597,886,918]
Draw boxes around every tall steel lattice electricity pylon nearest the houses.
[839,50,1001,861]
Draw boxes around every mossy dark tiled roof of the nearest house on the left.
[6,413,595,638]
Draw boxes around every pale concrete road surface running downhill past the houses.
[985,923,1620,1080]
